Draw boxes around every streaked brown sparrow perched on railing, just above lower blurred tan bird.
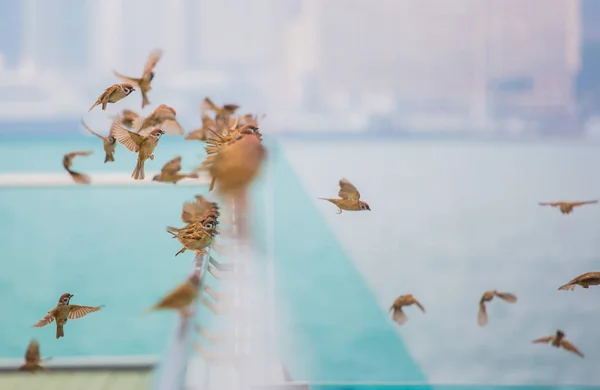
[167,207,219,256]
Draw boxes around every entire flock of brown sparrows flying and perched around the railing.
[15,50,600,372]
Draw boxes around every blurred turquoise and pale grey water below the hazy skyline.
[0,136,600,389]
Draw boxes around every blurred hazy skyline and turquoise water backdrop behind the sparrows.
[0,0,600,389]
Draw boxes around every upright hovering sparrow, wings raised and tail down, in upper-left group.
[110,122,164,180]
